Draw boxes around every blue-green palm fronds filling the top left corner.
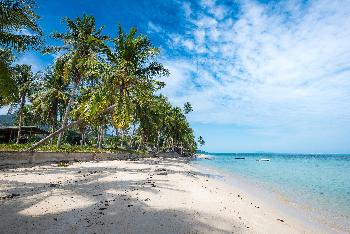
[0,0,42,52]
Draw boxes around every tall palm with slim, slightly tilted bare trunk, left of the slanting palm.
[45,15,107,147]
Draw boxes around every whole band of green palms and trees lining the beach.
[0,0,204,154]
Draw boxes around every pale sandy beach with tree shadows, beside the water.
[0,159,340,233]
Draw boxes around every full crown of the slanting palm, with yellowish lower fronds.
[100,25,169,144]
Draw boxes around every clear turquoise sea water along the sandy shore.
[198,153,350,220]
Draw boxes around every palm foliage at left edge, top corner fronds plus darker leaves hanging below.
[0,0,42,110]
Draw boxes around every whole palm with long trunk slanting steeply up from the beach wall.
[28,26,169,150]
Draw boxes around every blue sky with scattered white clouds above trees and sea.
[2,0,350,153]
